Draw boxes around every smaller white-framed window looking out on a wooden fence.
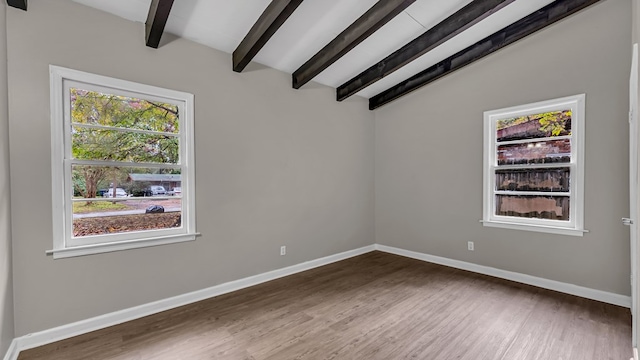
[483,94,585,236]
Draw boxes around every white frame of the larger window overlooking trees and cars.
[47,65,198,259]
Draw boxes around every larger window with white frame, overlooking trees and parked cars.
[49,66,197,258]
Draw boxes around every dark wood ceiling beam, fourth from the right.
[232,0,302,72]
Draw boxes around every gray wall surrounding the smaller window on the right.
[375,0,632,295]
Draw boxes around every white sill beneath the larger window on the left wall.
[46,233,200,259]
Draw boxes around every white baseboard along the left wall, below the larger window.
[4,245,374,360]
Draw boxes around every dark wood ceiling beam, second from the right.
[336,0,515,101]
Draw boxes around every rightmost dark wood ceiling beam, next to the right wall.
[369,0,600,110]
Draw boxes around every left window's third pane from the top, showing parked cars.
[71,165,182,198]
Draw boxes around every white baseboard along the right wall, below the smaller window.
[375,244,631,308]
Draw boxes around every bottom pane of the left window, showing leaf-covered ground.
[73,197,182,237]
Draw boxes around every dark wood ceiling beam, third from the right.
[292,0,416,89]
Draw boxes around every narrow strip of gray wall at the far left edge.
[0,1,13,356]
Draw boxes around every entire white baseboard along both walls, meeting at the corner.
[4,244,639,360]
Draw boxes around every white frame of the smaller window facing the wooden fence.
[482,94,587,236]
